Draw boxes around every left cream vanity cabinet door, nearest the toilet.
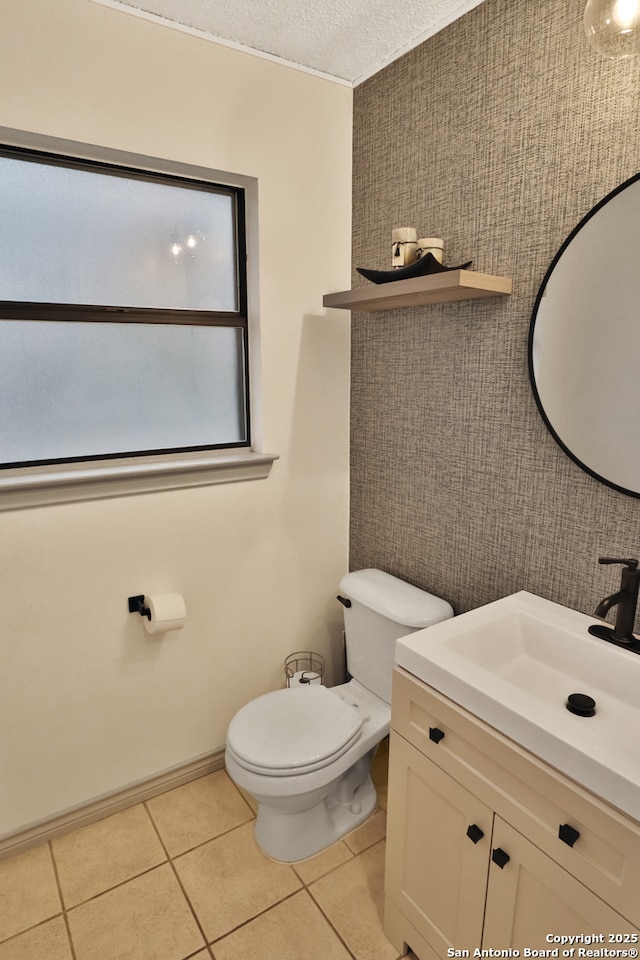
[386,732,493,957]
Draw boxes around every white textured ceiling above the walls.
[93,0,482,85]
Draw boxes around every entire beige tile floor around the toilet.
[0,750,408,960]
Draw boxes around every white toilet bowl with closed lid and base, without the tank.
[225,680,391,862]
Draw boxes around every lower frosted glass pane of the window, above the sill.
[0,320,247,465]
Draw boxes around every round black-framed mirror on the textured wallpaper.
[529,174,640,497]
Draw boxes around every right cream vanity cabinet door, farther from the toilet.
[482,817,637,944]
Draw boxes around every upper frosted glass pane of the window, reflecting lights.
[0,157,238,311]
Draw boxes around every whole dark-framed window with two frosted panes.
[0,138,273,510]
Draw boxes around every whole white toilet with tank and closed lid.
[225,569,453,863]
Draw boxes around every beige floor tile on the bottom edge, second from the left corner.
[68,864,204,960]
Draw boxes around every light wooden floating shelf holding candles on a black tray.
[322,270,511,311]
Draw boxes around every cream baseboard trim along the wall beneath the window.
[0,747,224,860]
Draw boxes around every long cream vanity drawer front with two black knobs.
[391,668,640,932]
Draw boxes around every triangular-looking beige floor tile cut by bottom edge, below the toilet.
[212,890,351,960]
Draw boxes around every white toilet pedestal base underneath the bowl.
[255,751,377,863]
